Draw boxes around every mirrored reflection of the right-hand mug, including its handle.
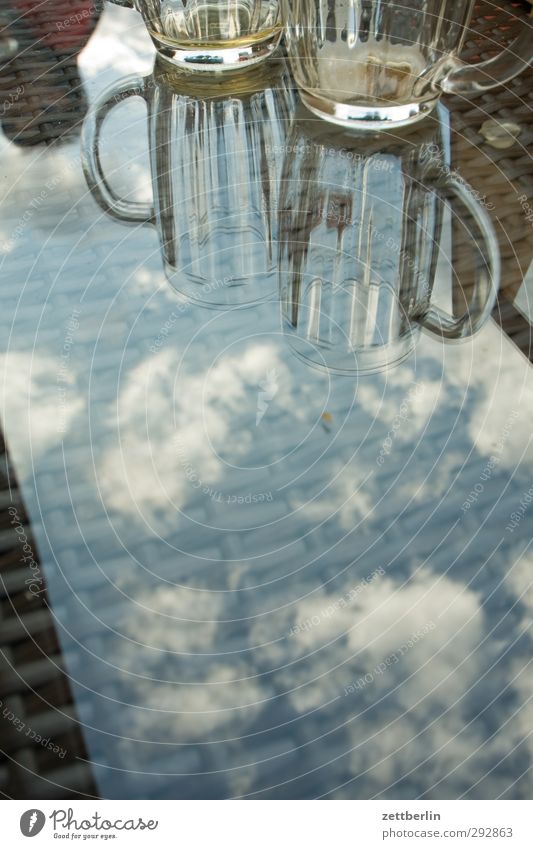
[279,110,500,374]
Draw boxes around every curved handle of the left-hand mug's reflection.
[81,76,155,224]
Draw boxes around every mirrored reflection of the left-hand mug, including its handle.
[82,61,294,307]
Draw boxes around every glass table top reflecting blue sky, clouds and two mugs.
[0,0,533,799]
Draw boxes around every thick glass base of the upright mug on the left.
[150,27,282,73]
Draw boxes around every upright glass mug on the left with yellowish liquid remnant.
[112,0,282,71]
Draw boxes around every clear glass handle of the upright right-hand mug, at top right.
[440,21,533,95]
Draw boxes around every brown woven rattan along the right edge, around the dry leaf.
[446,0,533,359]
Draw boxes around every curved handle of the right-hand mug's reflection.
[413,172,501,339]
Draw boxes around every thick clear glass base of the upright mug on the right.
[300,89,439,132]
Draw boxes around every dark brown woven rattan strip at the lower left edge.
[0,438,95,799]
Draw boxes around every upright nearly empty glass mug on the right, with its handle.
[281,0,533,130]
